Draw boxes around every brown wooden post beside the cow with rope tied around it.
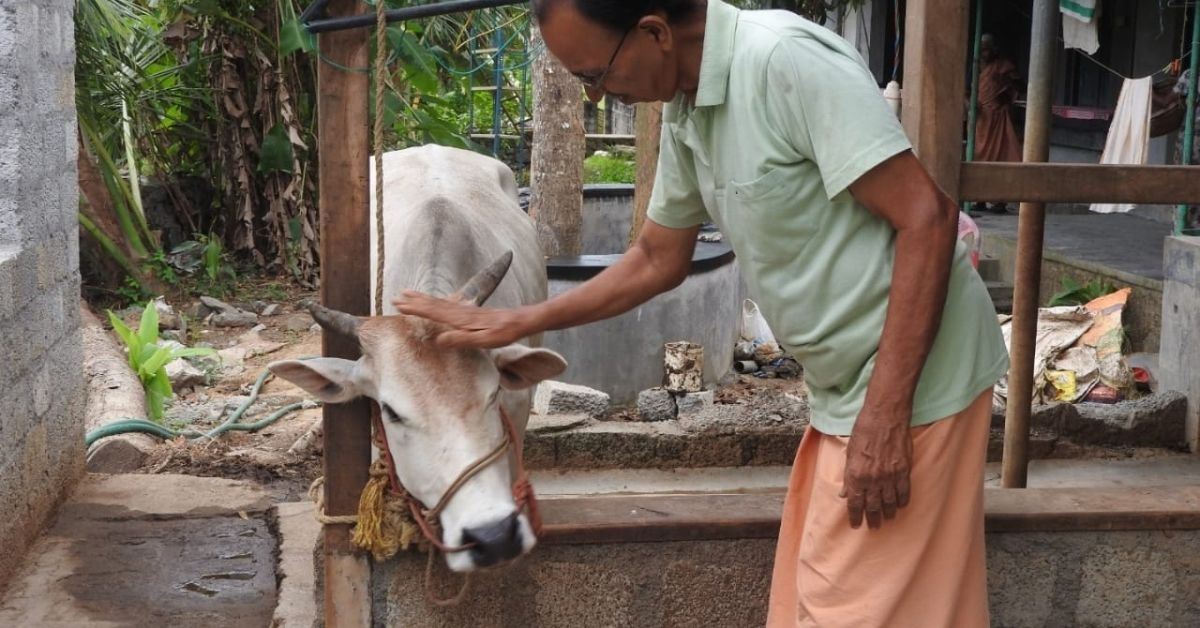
[317,0,371,628]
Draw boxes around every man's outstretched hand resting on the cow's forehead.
[391,291,530,349]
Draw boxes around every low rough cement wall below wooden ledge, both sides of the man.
[372,531,1200,628]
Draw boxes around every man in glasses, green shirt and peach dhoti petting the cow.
[396,0,1008,628]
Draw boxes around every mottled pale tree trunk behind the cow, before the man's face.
[529,24,587,256]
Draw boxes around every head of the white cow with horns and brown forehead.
[269,253,566,572]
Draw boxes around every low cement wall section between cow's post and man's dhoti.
[371,539,775,628]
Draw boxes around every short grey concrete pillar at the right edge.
[1158,237,1200,451]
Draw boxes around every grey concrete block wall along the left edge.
[0,0,84,585]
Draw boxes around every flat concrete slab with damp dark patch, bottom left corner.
[0,474,277,627]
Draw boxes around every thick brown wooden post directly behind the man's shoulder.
[901,0,967,202]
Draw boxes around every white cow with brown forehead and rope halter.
[270,145,566,572]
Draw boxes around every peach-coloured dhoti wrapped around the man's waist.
[767,388,991,628]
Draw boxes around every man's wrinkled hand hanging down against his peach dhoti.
[839,411,912,530]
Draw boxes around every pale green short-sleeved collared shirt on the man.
[648,0,1008,436]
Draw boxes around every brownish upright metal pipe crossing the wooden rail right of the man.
[1001,0,1058,489]
